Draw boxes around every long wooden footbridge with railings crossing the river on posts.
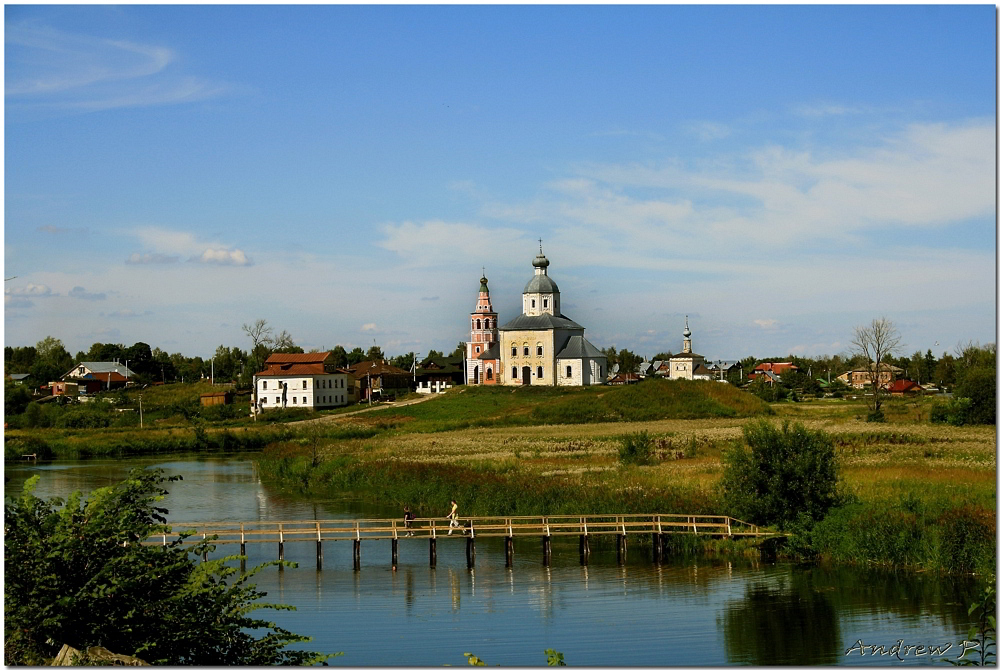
[149,514,779,570]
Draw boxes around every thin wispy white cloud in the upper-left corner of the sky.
[5,22,226,111]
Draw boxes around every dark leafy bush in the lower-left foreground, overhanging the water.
[4,470,328,665]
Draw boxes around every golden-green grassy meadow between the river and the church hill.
[256,407,996,573]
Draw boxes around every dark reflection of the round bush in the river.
[717,578,843,665]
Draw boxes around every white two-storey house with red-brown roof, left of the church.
[253,351,353,410]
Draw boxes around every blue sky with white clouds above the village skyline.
[4,5,996,359]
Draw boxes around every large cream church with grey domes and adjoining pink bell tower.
[466,243,608,386]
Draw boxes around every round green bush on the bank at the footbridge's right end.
[719,420,837,527]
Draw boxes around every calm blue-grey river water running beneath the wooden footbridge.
[4,456,976,666]
